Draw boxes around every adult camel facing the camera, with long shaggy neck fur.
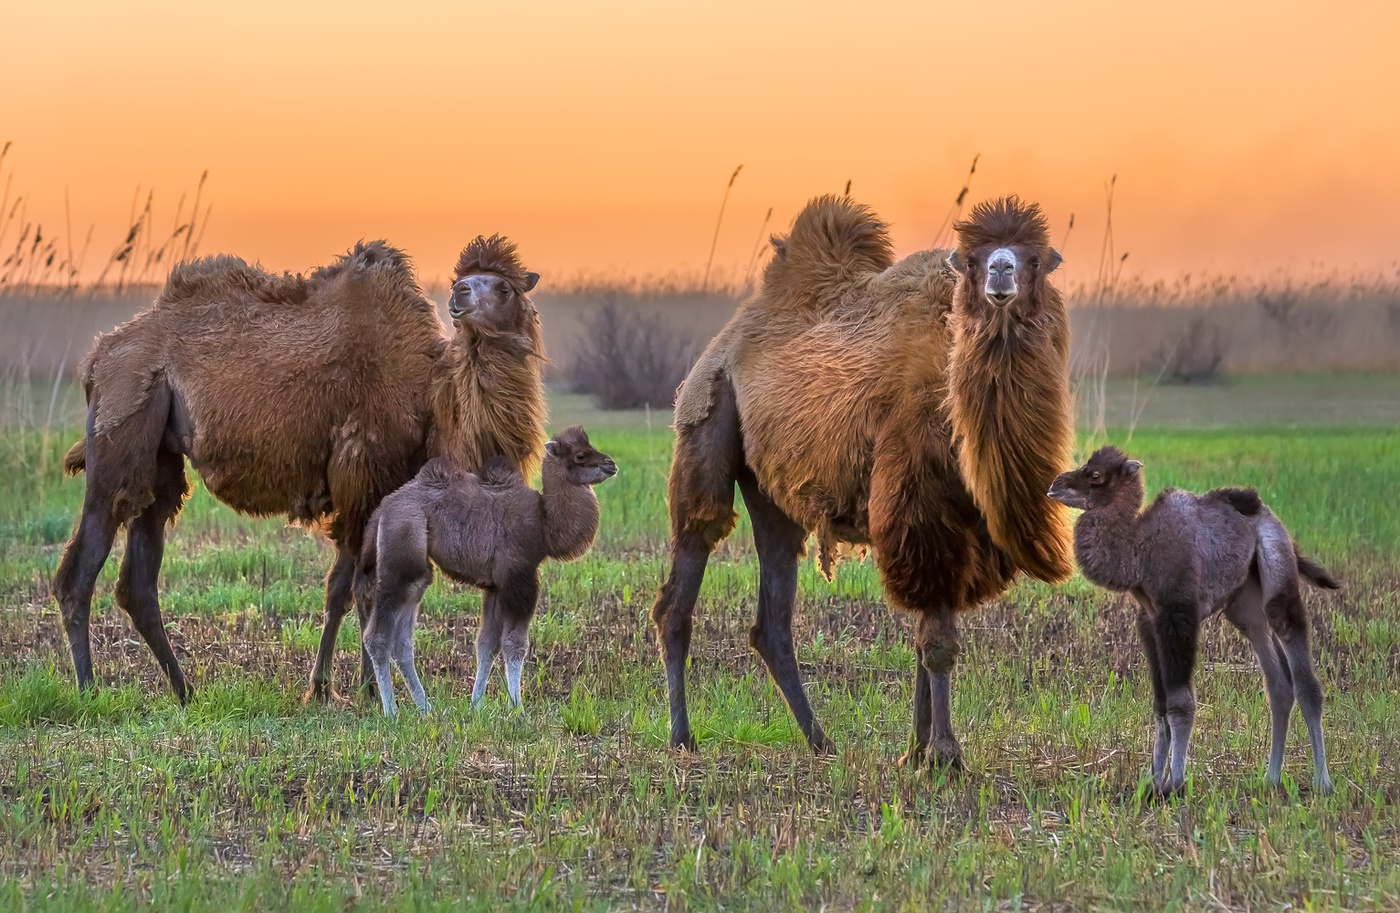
[652,196,1072,766]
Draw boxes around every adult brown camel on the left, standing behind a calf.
[55,235,545,702]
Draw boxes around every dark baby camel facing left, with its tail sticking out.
[1049,447,1340,793]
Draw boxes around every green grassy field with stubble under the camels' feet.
[0,378,1400,910]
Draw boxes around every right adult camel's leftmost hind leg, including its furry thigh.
[651,377,743,751]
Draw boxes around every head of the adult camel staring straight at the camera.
[948,196,1063,308]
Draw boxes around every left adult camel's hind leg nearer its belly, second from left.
[116,449,192,704]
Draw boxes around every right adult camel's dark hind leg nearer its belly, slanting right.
[739,472,830,752]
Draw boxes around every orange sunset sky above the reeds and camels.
[0,0,1400,281]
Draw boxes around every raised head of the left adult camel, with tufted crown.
[448,235,539,333]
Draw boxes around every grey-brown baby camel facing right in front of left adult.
[358,426,617,717]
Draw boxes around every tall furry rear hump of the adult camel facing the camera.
[763,195,895,305]
